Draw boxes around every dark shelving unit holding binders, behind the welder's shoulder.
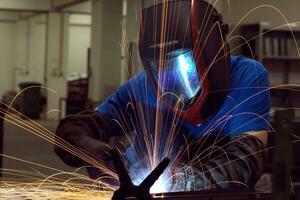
[241,22,300,105]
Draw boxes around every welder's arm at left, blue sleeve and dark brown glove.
[55,79,135,167]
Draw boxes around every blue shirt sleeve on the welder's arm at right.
[223,57,271,136]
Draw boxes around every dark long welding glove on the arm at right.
[172,134,267,191]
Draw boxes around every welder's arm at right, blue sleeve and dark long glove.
[175,60,270,190]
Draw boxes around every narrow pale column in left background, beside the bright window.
[45,13,68,119]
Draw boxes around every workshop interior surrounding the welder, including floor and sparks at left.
[0,0,300,200]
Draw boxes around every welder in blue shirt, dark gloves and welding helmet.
[55,0,270,191]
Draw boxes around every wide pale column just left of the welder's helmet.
[89,0,123,102]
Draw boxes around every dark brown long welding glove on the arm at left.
[55,110,127,167]
